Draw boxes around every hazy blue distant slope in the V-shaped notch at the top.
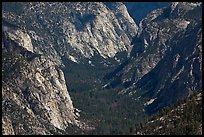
[124,2,170,25]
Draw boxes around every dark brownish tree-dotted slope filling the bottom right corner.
[131,92,202,135]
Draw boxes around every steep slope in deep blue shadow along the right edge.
[138,17,202,112]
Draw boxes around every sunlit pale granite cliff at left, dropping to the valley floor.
[2,24,78,134]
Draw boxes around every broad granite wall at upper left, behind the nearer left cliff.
[3,2,137,63]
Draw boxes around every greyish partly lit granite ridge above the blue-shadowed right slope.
[106,3,201,88]
